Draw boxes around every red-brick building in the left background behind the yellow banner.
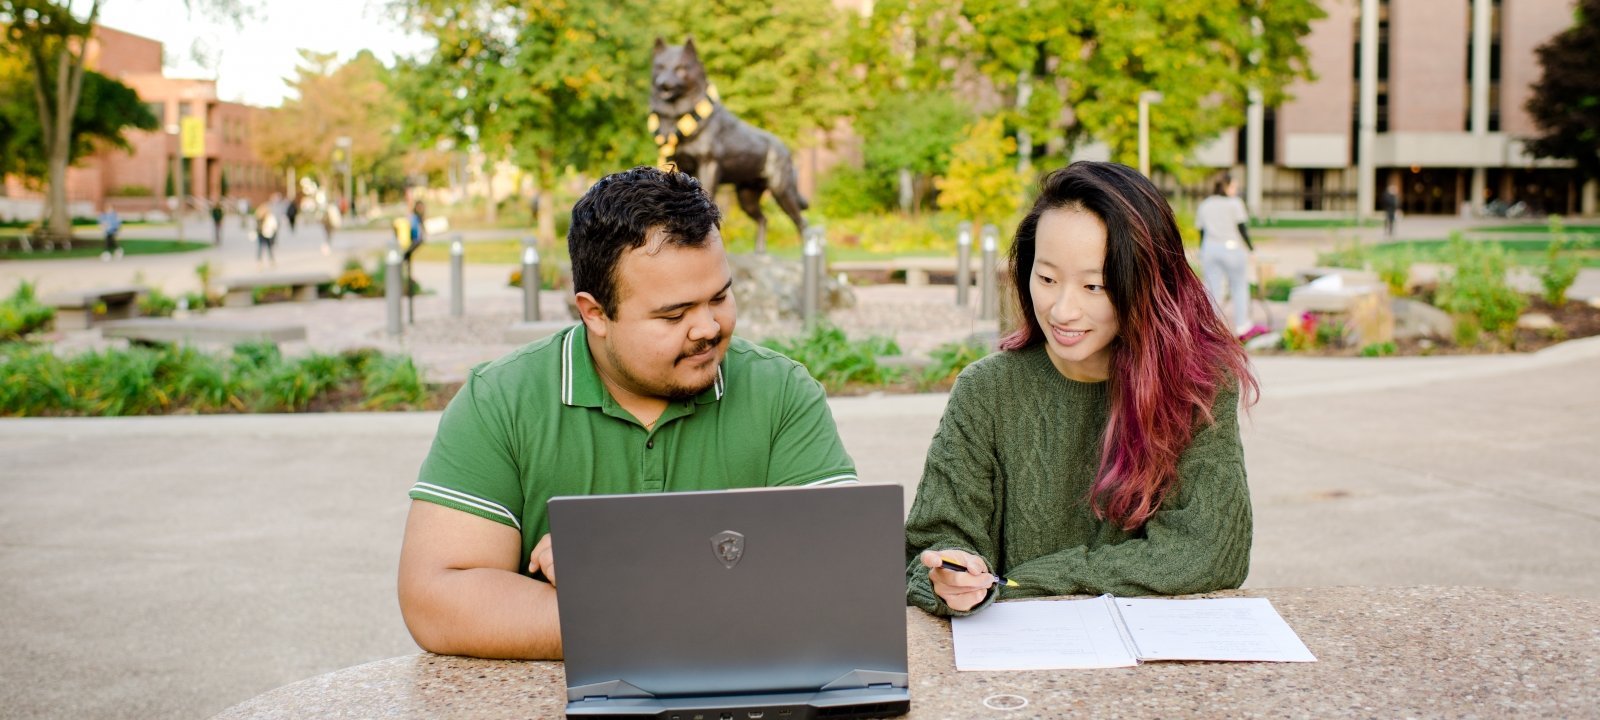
[5,26,283,216]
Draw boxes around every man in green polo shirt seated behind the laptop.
[400,168,856,659]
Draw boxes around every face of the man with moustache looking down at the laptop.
[586,227,736,400]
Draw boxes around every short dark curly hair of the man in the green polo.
[566,166,722,318]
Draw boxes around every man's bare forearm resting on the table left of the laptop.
[400,568,562,659]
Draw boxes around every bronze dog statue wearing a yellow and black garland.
[650,37,810,253]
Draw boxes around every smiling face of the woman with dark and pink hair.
[1027,208,1117,382]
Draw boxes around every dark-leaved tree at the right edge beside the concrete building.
[1528,0,1600,179]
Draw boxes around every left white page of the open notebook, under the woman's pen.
[950,598,1138,670]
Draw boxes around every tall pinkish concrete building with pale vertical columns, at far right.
[1237,0,1595,214]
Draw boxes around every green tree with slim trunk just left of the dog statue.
[402,0,654,245]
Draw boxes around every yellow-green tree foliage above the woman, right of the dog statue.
[851,0,1323,173]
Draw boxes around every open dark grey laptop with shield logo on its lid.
[549,485,910,720]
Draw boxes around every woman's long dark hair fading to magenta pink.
[1000,162,1261,531]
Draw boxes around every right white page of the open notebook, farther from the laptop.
[1117,597,1317,662]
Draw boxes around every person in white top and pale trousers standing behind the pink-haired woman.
[1195,176,1256,336]
